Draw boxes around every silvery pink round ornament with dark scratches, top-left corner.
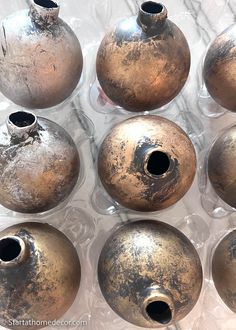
[0,0,83,109]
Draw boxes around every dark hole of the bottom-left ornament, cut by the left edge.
[0,238,21,262]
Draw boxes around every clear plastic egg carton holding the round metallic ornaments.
[0,0,236,330]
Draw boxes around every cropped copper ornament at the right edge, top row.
[203,24,236,112]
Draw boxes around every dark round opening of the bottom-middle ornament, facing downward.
[146,301,172,324]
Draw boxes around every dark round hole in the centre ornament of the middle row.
[147,151,170,175]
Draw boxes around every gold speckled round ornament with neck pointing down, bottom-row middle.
[98,220,202,328]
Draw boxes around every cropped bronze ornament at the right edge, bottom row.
[212,230,236,313]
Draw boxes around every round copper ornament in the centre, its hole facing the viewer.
[98,115,196,212]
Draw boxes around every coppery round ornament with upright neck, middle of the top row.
[96,1,190,112]
